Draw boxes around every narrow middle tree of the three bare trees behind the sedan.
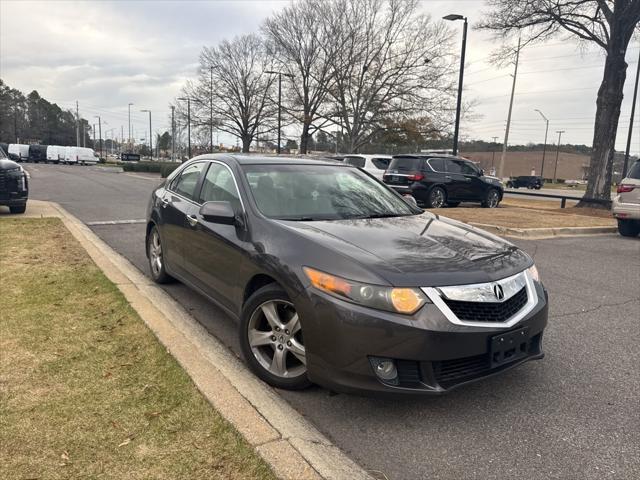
[263,0,336,153]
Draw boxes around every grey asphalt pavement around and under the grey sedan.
[20,165,640,480]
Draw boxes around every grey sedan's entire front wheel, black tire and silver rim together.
[240,283,311,390]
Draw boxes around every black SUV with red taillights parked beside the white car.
[383,154,504,208]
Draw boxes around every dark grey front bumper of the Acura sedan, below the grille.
[296,282,548,395]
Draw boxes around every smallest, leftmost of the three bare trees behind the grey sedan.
[180,34,276,152]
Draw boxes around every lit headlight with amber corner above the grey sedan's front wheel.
[303,267,427,315]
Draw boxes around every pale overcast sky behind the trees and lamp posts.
[0,0,640,154]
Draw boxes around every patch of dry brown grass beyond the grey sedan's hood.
[430,200,616,228]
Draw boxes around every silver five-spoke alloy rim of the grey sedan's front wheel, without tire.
[247,300,307,378]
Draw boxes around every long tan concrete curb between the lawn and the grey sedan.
[34,202,373,480]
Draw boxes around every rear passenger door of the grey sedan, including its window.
[160,162,206,276]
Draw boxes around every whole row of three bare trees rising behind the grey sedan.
[175,0,456,153]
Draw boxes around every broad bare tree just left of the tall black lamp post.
[325,0,455,152]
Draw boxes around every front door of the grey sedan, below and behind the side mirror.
[184,162,245,309]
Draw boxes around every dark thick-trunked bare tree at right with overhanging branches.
[480,0,640,206]
